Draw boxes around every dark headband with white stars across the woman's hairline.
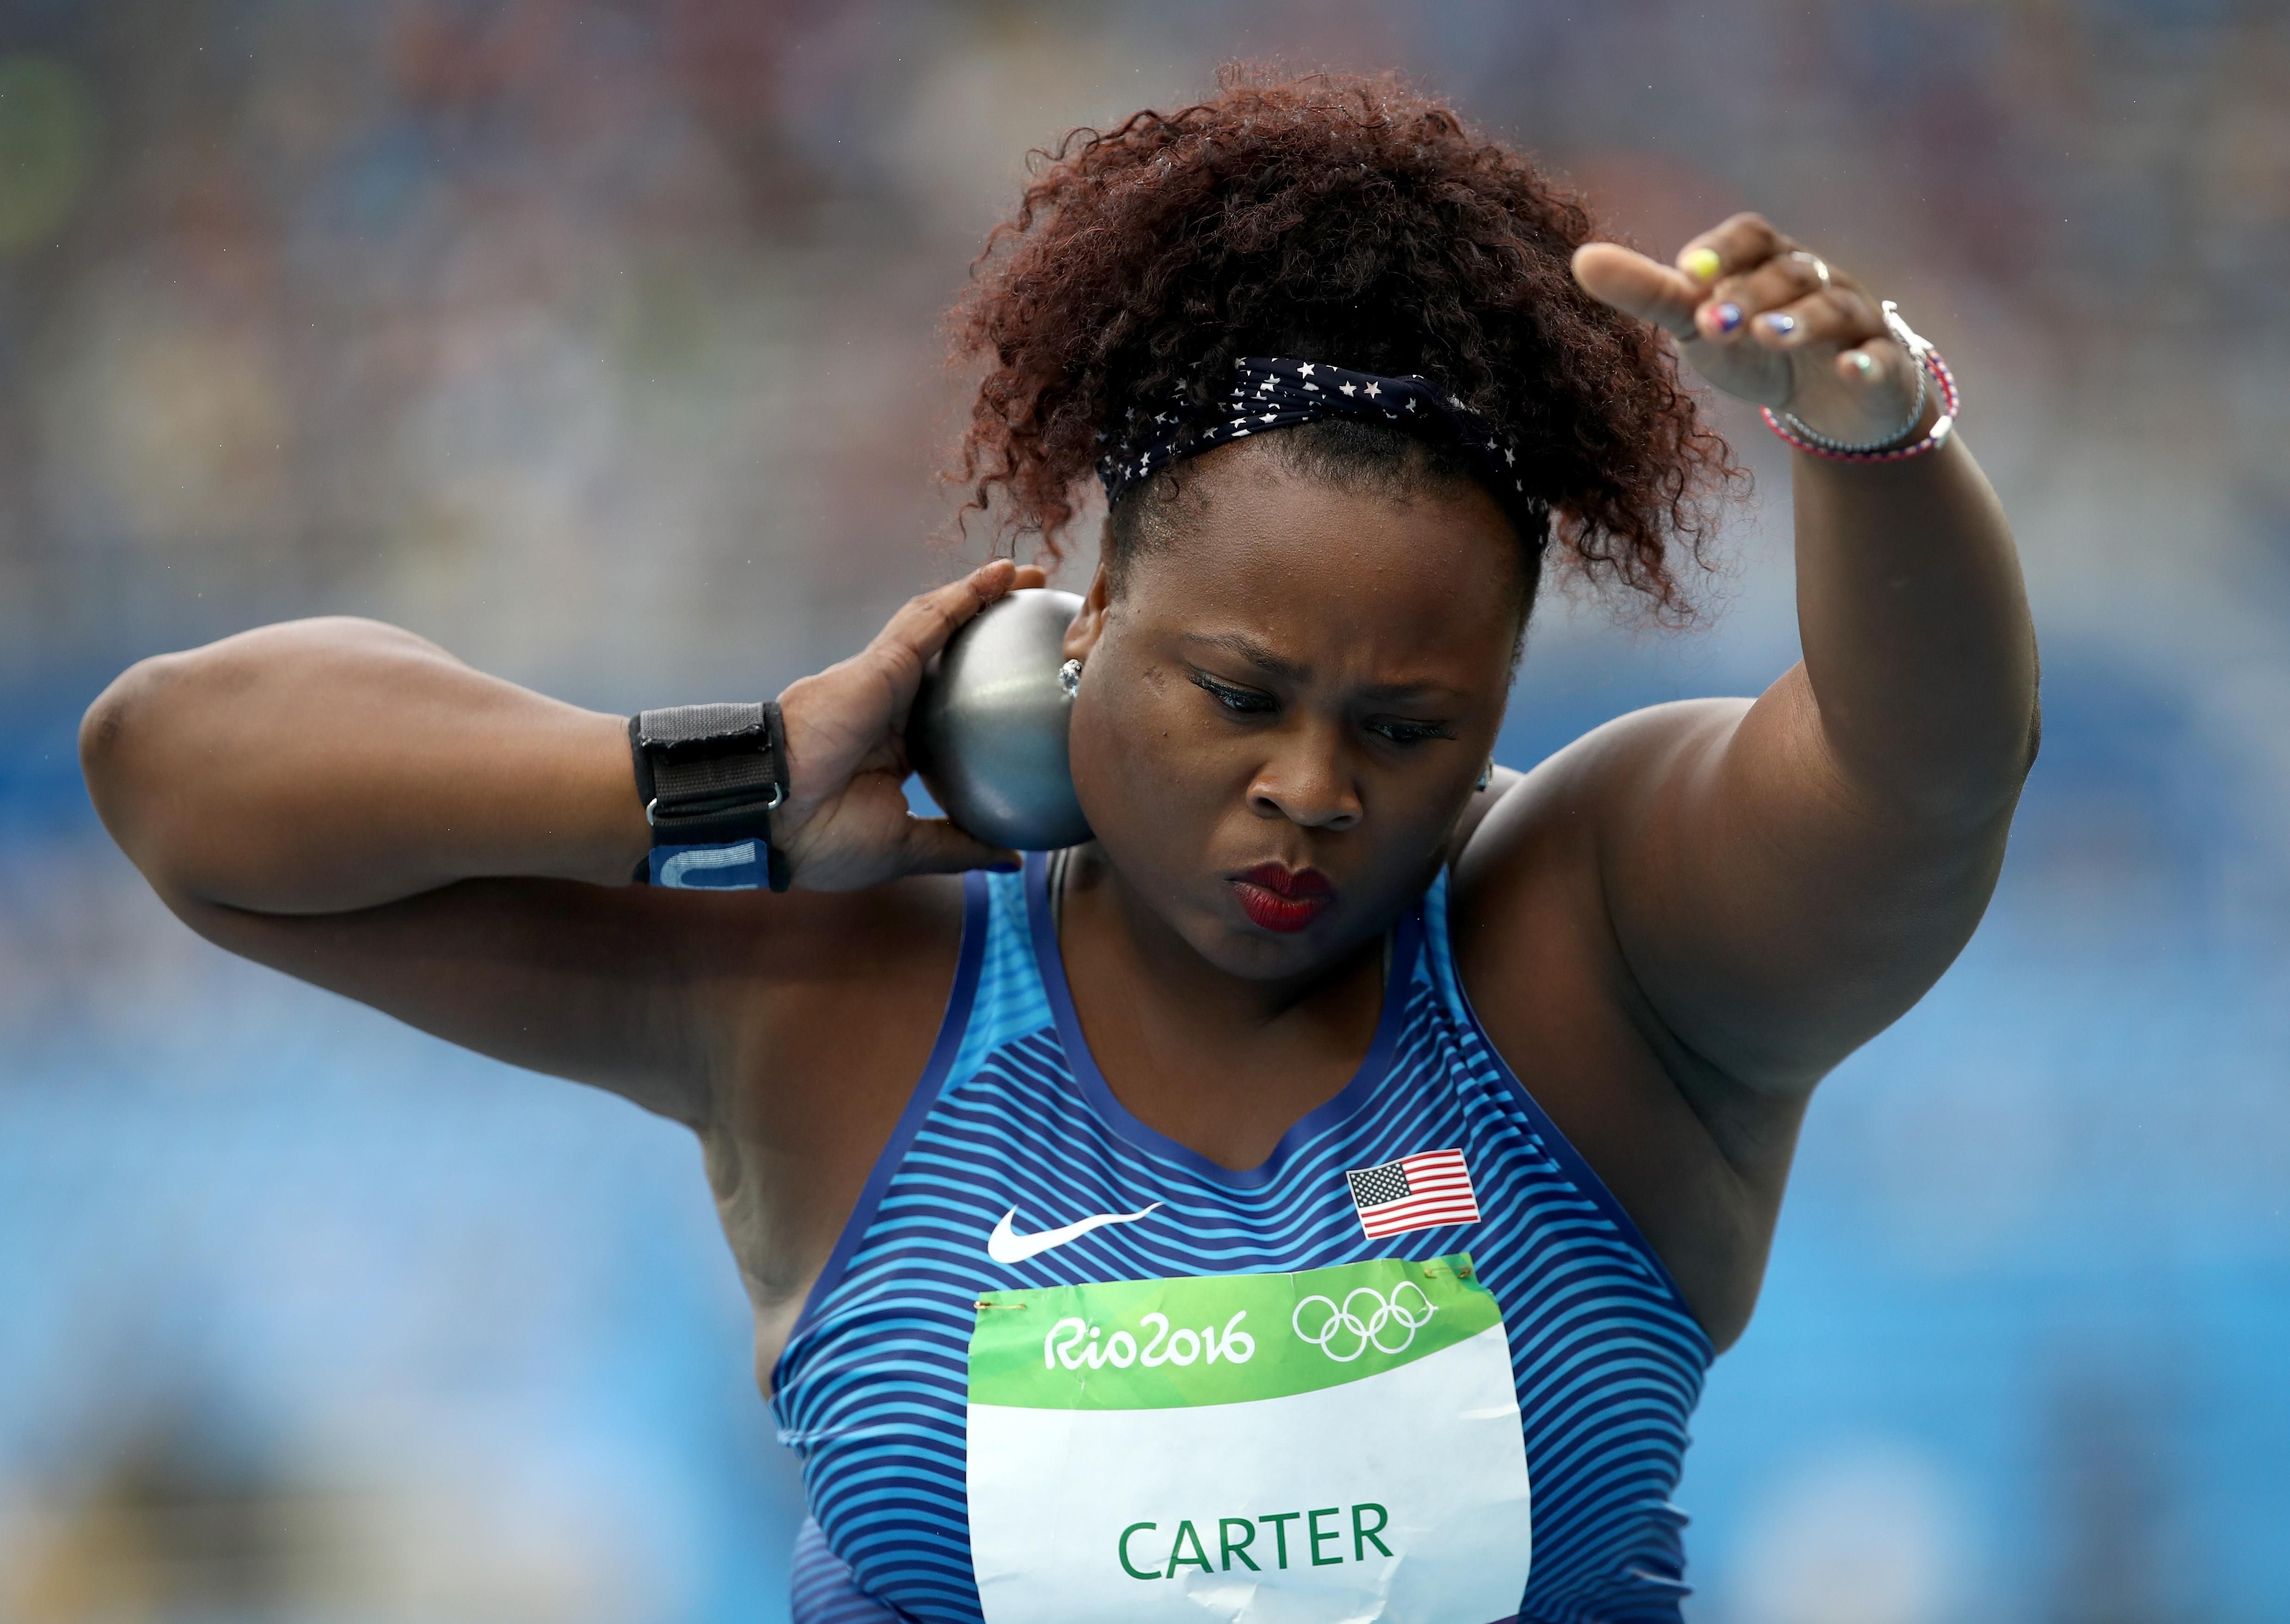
[1097,355,1550,550]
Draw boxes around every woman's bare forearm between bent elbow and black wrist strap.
[80,621,651,914]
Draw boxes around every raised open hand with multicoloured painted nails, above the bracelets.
[1573,215,1937,444]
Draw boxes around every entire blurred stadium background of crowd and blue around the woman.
[0,0,2290,1624]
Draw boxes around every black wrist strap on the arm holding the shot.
[627,701,788,891]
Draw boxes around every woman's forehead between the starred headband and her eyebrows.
[1122,442,1525,683]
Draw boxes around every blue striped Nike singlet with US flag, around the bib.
[772,857,1713,1624]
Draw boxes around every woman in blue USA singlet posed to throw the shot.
[82,78,2036,1624]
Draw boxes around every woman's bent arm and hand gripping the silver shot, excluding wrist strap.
[80,564,1031,1127]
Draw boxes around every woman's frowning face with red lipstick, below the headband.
[1065,442,1523,978]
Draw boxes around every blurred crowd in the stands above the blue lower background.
[0,0,2290,674]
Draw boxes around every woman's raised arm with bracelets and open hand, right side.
[1521,215,2038,1095]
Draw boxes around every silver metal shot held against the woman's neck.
[907,586,1090,852]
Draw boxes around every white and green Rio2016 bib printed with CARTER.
[969,1253,1530,1624]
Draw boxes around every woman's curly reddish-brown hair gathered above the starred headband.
[950,67,1736,616]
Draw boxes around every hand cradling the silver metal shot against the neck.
[772,559,1047,891]
